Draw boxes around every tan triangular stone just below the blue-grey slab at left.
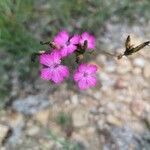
[34,109,50,125]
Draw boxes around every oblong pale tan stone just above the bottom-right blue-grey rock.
[106,115,123,127]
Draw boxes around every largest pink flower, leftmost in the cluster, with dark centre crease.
[40,52,69,84]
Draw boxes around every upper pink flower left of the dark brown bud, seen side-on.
[54,31,80,57]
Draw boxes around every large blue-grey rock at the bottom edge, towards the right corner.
[101,126,143,150]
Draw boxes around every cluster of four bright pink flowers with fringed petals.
[39,31,97,90]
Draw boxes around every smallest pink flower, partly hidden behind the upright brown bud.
[79,32,95,50]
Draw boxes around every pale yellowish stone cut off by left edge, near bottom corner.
[0,124,9,145]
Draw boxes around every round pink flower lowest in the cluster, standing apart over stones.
[73,64,97,90]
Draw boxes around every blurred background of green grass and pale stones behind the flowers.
[0,0,150,150]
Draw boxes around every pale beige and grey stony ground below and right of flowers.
[0,22,150,150]
